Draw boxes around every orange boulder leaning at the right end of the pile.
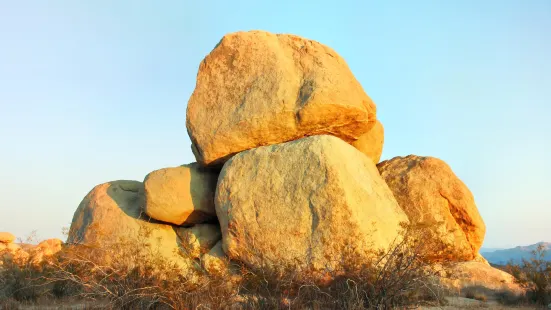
[378,155,486,261]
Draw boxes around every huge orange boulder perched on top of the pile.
[187,31,376,165]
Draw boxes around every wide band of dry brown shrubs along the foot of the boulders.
[0,226,452,309]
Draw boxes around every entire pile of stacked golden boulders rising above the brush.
[68,31,496,284]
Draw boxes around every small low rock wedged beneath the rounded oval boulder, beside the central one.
[178,224,222,258]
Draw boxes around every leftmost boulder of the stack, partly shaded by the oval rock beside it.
[67,180,194,268]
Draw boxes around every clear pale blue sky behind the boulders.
[0,0,551,247]
